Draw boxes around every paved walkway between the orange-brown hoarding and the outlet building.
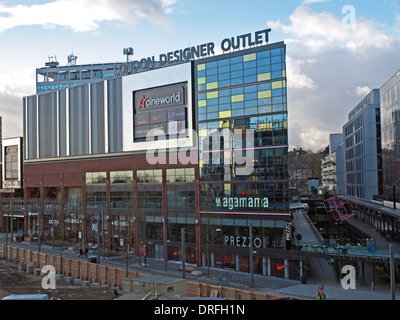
[0,237,400,300]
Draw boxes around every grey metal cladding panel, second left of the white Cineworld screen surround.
[90,82,105,154]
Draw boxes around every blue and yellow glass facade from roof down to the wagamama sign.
[195,43,289,215]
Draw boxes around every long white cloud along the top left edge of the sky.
[0,0,176,32]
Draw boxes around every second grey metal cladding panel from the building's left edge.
[38,92,57,158]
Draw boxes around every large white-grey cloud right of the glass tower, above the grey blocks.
[267,6,400,150]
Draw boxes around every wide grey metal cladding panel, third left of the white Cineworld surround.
[69,85,89,156]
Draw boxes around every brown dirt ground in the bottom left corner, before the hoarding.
[0,260,122,300]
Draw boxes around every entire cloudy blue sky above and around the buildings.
[0,0,400,150]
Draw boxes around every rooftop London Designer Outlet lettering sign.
[116,29,271,77]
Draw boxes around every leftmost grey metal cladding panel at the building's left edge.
[26,96,37,159]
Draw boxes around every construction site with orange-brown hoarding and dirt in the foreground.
[0,243,287,300]
